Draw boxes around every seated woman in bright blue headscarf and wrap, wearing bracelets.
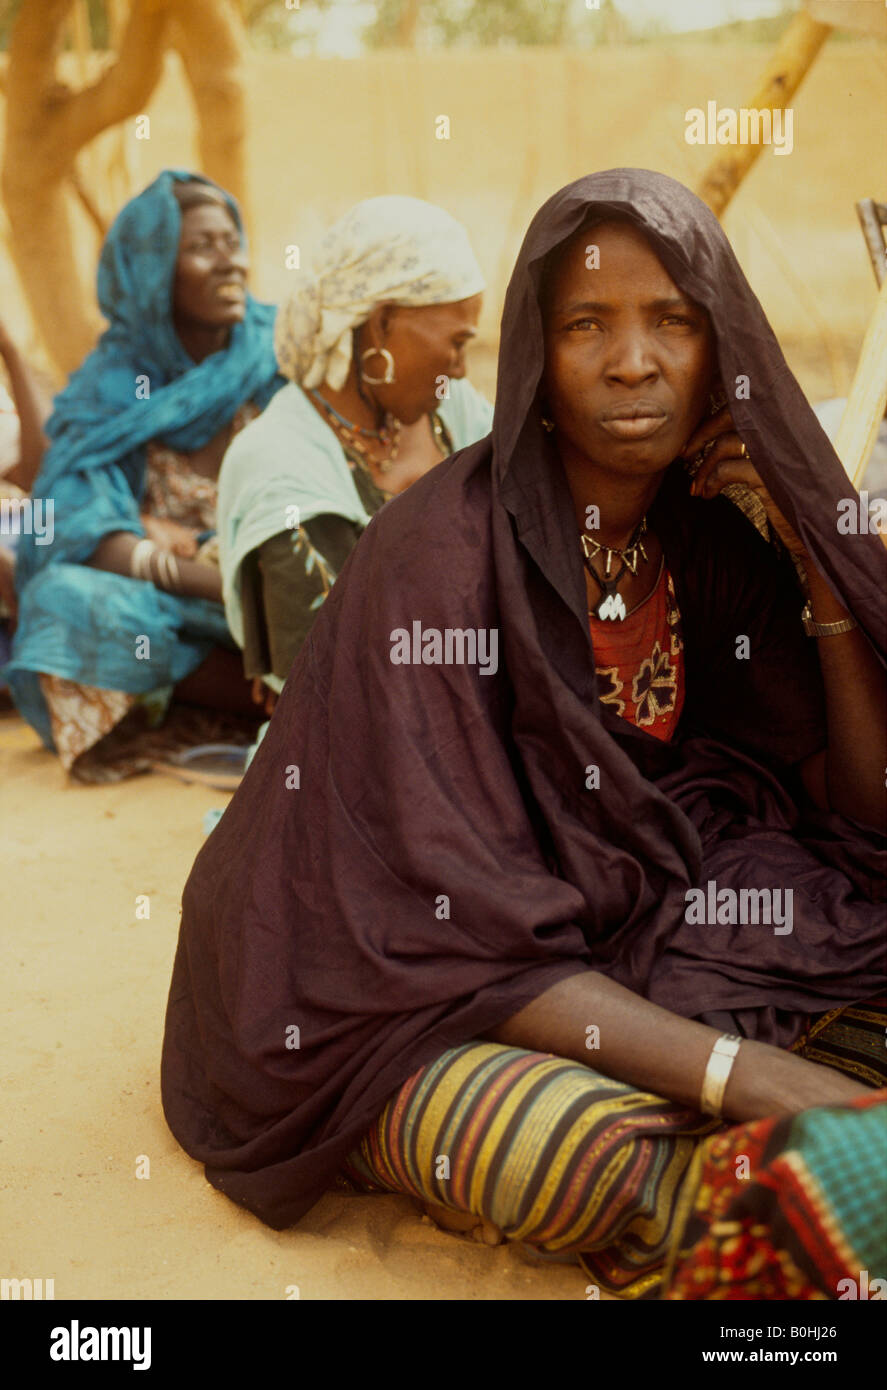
[7,170,282,781]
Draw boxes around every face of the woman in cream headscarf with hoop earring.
[357,303,482,425]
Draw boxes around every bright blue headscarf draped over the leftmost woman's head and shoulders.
[17,170,284,589]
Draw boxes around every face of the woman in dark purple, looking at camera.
[544,222,715,477]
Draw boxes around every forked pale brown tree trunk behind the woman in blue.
[0,0,246,375]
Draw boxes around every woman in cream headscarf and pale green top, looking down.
[218,197,492,691]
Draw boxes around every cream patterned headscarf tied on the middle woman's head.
[274,196,484,391]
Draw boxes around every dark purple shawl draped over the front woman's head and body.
[163,170,887,1227]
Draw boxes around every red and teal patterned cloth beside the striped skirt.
[666,1095,887,1300]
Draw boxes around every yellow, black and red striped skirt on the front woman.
[341,1001,887,1298]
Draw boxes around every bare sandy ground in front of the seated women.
[0,714,597,1300]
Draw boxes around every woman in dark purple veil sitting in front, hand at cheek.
[163,170,887,1297]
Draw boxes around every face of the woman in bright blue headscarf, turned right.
[172,203,249,328]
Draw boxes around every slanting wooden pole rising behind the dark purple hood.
[697,10,831,217]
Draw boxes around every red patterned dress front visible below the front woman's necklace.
[588,560,684,742]
